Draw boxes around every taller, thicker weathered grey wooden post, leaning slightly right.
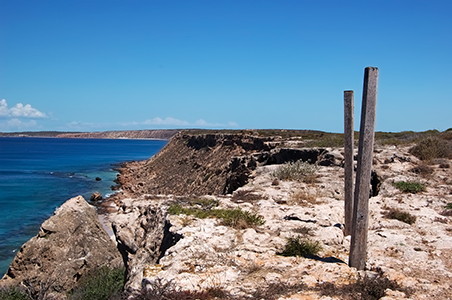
[349,67,378,270]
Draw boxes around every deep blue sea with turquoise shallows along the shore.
[0,137,166,277]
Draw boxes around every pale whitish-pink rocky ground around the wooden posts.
[101,142,452,299]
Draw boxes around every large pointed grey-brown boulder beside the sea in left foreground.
[0,196,122,299]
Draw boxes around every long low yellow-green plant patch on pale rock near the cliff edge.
[168,204,265,229]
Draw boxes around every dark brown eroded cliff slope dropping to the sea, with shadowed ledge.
[112,133,336,197]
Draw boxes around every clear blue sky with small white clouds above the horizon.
[0,0,452,132]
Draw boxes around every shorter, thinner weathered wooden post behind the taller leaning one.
[344,91,354,235]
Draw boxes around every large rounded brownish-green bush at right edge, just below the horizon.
[410,137,452,160]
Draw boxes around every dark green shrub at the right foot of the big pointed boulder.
[69,267,124,300]
